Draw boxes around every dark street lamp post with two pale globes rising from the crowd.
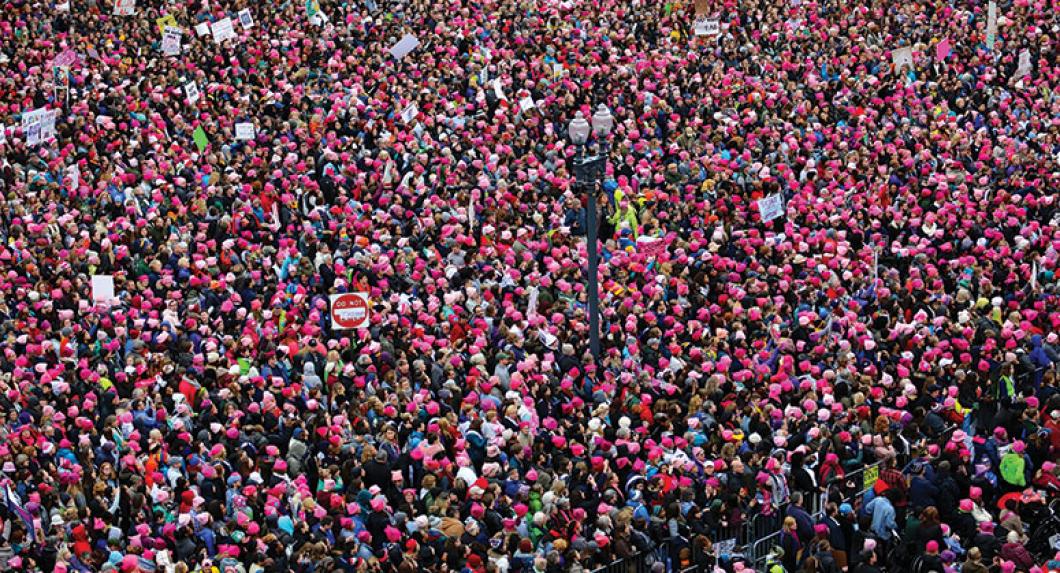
[567,104,615,364]
